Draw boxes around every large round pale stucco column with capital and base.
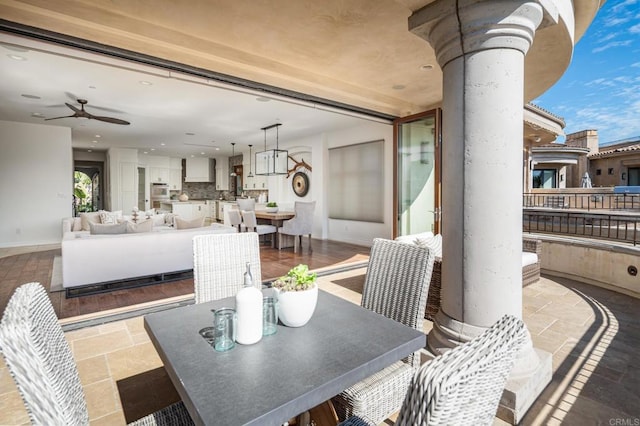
[409,0,551,423]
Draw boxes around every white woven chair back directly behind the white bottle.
[193,232,262,303]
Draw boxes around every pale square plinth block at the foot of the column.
[496,348,553,425]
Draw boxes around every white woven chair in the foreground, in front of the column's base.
[340,315,527,426]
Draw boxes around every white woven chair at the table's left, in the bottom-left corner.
[0,282,193,426]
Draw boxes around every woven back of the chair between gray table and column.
[361,238,435,367]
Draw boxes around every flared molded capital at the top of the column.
[409,0,546,68]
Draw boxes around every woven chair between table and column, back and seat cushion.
[332,238,435,423]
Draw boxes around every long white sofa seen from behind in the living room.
[62,220,237,290]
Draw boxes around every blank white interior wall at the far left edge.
[0,121,73,247]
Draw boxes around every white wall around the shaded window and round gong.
[276,122,394,246]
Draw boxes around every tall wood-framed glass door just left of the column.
[394,110,441,236]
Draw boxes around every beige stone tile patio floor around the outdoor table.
[0,269,640,425]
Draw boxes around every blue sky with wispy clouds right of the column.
[532,0,640,144]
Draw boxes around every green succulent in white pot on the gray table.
[271,264,318,327]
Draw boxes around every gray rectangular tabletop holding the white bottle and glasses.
[144,291,426,425]
